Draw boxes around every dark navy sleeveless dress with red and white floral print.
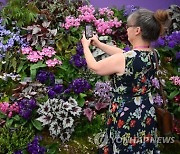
[99,50,160,154]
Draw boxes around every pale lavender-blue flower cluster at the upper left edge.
[0,19,27,57]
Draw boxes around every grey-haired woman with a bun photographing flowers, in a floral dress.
[81,9,170,154]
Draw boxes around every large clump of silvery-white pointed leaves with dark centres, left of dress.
[37,97,82,142]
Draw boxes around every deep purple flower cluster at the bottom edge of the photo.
[27,136,46,154]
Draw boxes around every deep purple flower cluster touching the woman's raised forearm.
[70,43,87,68]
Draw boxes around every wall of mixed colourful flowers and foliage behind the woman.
[0,0,180,154]
